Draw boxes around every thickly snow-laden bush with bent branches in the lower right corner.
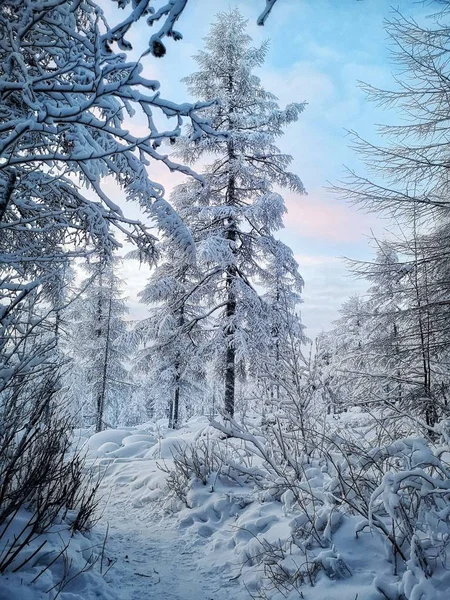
[312,428,450,600]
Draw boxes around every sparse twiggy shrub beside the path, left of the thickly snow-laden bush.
[208,418,356,594]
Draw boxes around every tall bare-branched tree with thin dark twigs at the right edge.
[330,0,450,430]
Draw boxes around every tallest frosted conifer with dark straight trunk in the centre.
[172,9,304,414]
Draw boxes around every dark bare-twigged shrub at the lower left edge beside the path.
[0,369,98,573]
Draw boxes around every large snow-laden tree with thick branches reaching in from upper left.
[0,0,225,336]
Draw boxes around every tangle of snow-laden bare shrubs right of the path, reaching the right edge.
[207,412,450,600]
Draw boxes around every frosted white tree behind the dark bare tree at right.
[329,234,448,429]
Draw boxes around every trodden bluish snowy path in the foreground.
[96,464,250,600]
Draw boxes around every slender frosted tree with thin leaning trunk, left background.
[69,260,133,431]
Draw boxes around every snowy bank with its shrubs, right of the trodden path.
[81,413,450,600]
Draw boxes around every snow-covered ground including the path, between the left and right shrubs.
[0,413,450,600]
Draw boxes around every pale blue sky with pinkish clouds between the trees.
[109,0,425,337]
